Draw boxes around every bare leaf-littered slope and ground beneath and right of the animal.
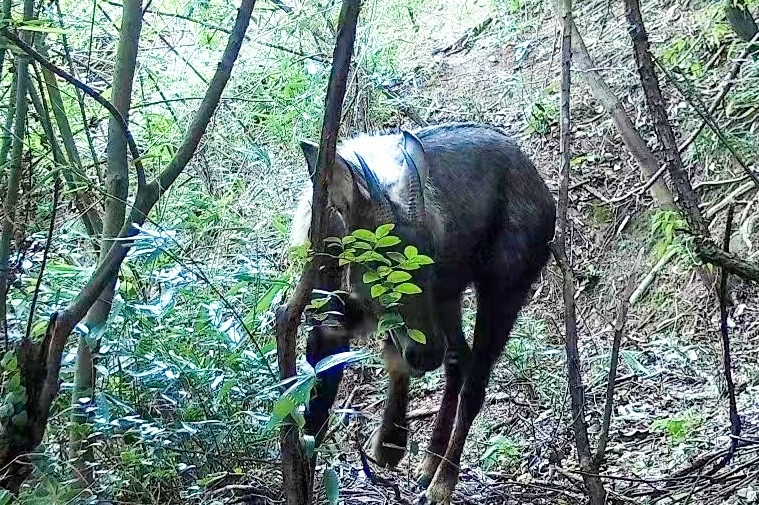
[208,2,759,504]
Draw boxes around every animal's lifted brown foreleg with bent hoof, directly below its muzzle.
[372,339,409,467]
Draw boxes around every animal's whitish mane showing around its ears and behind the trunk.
[290,130,444,247]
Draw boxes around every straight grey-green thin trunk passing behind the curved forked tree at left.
[69,0,142,486]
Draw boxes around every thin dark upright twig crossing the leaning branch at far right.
[719,204,741,466]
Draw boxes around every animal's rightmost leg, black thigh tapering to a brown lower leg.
[420,281,529,504]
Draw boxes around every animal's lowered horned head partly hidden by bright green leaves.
[301,131,447,372]
